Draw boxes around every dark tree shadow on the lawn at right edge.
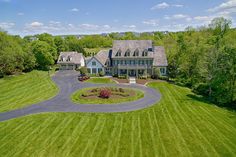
[187,94,236,112]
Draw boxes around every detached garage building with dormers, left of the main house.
[57,52,85,70]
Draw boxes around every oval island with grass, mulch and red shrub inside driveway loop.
[71,87,144,104]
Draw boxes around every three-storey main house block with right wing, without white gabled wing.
[111,40,168,77]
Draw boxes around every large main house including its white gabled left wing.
[59,40,168,77]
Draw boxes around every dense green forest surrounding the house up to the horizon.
[0,18,236,107]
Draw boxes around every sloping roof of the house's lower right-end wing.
[153,46,168,66]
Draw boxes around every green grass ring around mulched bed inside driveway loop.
[71,88,144,104]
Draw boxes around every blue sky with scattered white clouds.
[0,0,236,36]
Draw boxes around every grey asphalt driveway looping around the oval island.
[0,71,161,121]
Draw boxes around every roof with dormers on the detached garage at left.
[57,52,84,64]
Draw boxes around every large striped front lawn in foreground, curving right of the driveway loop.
[0,83,236,157]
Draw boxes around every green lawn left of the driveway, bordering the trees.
[0,71,58,112]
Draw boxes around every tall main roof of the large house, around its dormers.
[112,40,153,58]
